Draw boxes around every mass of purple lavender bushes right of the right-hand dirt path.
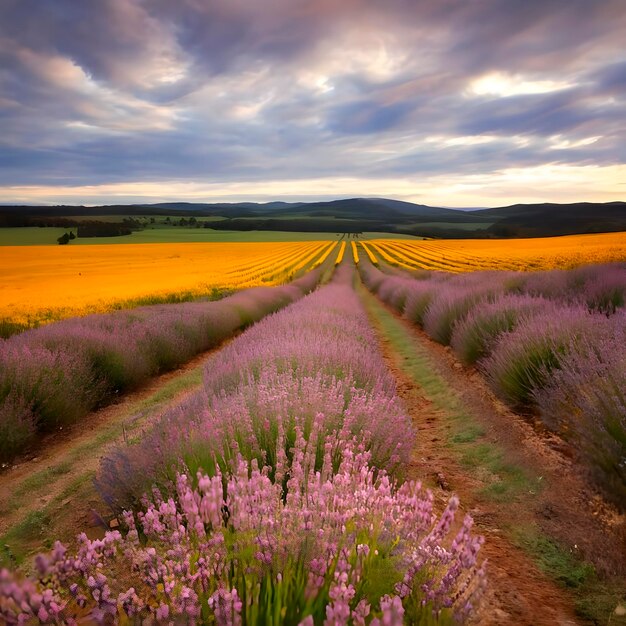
[361,264,626,506]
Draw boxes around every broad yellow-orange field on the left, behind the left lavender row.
[0,241,336,323]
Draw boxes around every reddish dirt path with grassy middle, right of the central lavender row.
[364,286,626,626]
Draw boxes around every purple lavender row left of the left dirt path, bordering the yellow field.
[0,270,321,461]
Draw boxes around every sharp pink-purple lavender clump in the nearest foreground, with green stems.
[0,433,485,626]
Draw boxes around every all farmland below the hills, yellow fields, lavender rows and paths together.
[0,233,626,625]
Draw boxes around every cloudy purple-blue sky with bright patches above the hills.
[0,0,626,207]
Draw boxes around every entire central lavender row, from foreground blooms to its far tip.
[0,268,485,626]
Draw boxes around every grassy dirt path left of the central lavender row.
[0,340,230,565]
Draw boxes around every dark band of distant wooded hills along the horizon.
[0,198,626,238]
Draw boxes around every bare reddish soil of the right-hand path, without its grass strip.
[365,288,626,626]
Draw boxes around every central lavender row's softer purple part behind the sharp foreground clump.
[98,268,414,511]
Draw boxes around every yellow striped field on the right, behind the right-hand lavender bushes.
[361,232,626,272]
